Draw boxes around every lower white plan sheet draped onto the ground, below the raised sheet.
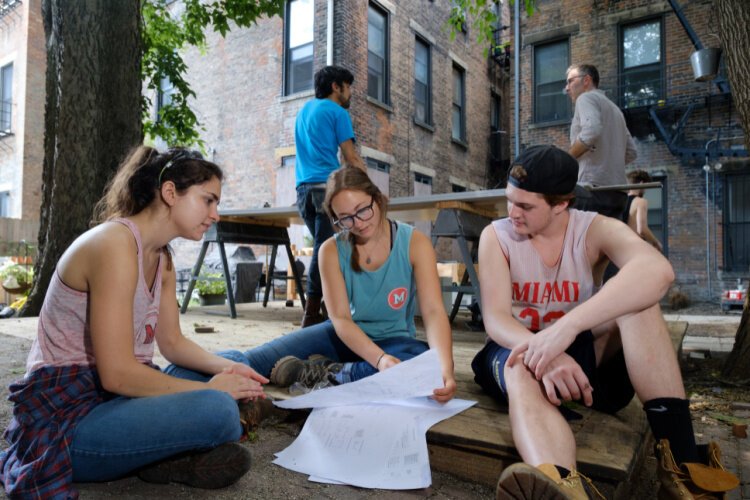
[273,398,475,490]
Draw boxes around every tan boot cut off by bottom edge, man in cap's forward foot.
[495,462,604,500]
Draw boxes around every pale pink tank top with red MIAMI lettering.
[492,209,598,332]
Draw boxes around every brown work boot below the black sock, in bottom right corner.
[656,439,740,500]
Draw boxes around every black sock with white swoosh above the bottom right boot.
[643,398,699,465]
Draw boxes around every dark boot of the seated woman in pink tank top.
[138,443,251,489]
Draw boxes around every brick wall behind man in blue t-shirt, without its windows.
[171,0,507,267]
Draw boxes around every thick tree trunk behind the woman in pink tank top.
[21,0,143,316]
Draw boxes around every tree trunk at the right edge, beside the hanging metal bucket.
[715,0,750,380]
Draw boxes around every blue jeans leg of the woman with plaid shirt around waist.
[70,389,242,482]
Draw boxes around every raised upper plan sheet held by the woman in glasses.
[274,349,443,410]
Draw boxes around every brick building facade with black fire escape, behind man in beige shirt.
[511,0,750,300]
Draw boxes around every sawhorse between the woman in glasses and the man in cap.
[432,203,492,323]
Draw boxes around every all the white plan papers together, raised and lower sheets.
[273,351,475,490]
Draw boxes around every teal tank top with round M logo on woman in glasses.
[336,223,417,340]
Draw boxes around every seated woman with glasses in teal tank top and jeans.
[168,167,456,401]
